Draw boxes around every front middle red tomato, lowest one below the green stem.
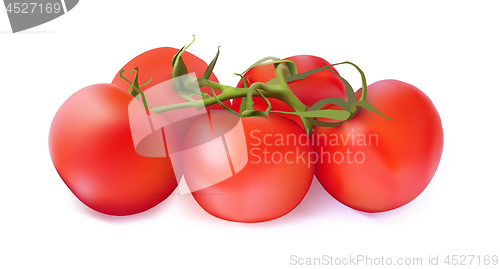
[182,111,314,223]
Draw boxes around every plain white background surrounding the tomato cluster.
[0,0,500,268]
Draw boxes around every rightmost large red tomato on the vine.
[312,80,443,212]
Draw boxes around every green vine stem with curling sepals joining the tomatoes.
[142,35,391,135]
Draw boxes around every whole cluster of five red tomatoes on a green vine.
[49,41,443,223]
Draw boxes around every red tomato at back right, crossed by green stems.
[233,55,346,126]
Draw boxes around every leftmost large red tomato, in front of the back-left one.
[49,84,177,215]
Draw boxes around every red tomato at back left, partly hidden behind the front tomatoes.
[111,47,231,110]
